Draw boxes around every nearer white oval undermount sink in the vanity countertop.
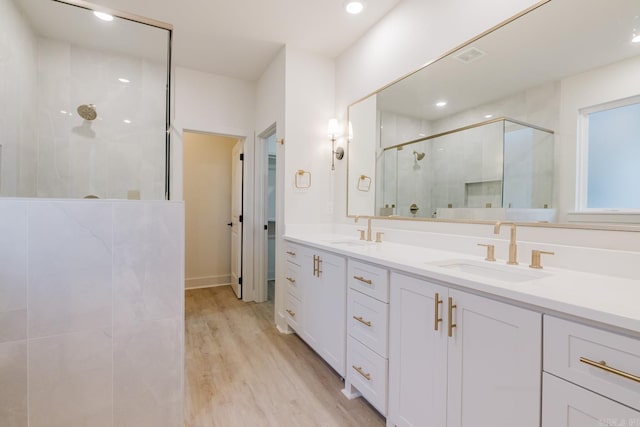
[429,259,549,283]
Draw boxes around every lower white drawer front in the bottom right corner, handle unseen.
[542,372,640,427]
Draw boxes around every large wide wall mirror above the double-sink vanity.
[347,0,640,227]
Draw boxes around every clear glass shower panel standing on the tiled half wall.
[0,0,171,200]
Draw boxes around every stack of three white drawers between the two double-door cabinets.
[344,259,389,415]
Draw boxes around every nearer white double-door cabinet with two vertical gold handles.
[387,272,542,427]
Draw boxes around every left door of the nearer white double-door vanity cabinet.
[389,273,448,427]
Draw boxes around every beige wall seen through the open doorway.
[183,132,237,288]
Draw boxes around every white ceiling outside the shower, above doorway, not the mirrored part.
[85,0,400,80]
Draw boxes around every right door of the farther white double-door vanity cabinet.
[316,251,347,378]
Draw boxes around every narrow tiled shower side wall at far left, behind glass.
[0,0,38,197]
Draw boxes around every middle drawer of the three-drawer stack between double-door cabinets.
[347,289,389,358]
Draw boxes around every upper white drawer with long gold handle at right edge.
[543,316,640,410]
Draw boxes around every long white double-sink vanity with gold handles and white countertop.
[285,233,640,427]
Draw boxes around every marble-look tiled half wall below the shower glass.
[0,199,184,427]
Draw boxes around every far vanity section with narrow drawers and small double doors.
[285,243,346,377]
